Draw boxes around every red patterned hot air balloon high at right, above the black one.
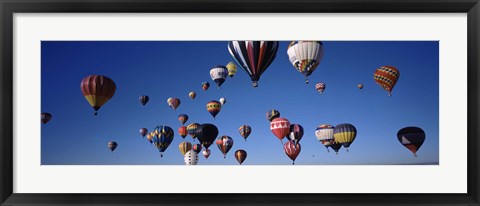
[373,66,400,96]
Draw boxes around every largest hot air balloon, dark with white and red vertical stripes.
[228,41,278,87]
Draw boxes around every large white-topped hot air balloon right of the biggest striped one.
[287,41,323,84]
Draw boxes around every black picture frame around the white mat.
[0,0,480,206]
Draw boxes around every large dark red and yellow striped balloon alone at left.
[80,75,117,115]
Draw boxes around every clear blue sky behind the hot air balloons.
[39,41,439,165]
